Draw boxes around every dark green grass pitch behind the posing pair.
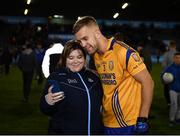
[0,64,180,135]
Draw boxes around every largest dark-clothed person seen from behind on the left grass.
[18,43,37,102]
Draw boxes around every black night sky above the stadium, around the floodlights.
[0,0,180,21]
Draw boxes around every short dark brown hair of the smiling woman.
[59,40,86,67]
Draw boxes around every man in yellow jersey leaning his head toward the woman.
[73,16,154,135]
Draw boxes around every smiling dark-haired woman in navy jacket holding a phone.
[40,40,103,135]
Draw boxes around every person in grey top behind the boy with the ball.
[162,40,176,107]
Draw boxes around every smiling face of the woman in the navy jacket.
[66,49,85,72]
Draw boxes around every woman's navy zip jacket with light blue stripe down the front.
[40,68,103,135]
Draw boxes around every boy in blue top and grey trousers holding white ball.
[162,52,180,126]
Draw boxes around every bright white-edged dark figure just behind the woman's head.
[42,43,64,78]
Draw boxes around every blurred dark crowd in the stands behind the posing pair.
[0,17,180,74]
